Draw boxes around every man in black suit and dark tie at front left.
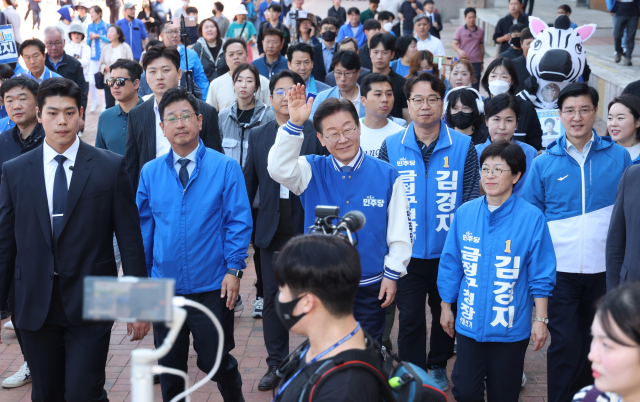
[0,78,149,402]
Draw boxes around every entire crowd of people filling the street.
[0,0,640,402]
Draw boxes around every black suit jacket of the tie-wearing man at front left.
[0,141,147,331]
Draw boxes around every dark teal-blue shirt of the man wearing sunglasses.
[96,98,144,156]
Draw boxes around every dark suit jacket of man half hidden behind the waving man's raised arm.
[244,120,326,248]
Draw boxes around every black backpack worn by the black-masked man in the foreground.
[276,332,447,402]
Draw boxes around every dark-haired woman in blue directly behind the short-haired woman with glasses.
[476,94,538,197]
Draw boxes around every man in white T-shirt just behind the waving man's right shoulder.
[360,73,404,158]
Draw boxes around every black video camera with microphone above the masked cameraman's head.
[307,205,367,246]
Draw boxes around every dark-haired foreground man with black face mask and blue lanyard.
[275,235,381,402]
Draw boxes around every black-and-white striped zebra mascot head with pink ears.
[527,15,596,83]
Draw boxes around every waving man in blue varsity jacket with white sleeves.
[267,84,412,343]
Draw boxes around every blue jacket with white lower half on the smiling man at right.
[522,132,631,274]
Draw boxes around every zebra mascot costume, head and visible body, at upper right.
[518,15,596,110]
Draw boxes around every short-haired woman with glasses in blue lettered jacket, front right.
[438,141,556,402]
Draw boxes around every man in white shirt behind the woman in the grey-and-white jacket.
[207,38,271,111]
